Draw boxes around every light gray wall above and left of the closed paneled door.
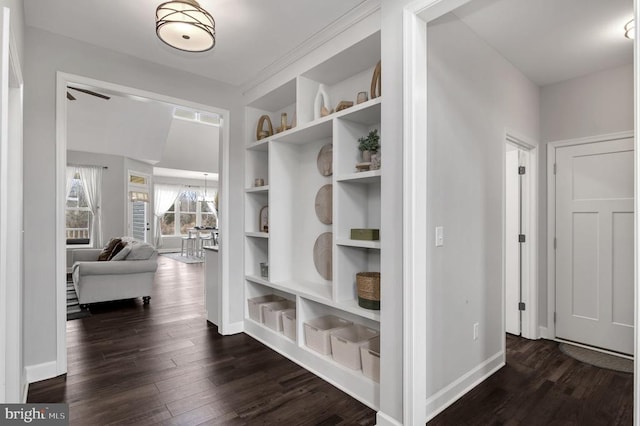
[538,64,633,327]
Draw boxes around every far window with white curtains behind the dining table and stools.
[160,188,218,236]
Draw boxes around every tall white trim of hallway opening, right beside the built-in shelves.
[402,0,470,425]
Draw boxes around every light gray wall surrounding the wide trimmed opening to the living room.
[24,27,244,365]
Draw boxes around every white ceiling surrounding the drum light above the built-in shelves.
[24,0,370,86]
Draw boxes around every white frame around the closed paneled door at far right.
[540,130,638,344]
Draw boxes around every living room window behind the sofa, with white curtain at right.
[66,173,93,244]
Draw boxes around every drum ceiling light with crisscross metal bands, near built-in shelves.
[156,0,216,52]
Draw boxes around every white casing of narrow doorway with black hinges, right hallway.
[502,129,540,339]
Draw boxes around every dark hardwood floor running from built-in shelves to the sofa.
[28,257,375,425]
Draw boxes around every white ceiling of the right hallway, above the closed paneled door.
[454,0,633,86]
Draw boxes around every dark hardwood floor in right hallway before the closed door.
[428,335,633,426]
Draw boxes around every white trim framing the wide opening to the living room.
[56,71,230,375]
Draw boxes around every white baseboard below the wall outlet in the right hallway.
[425,351,505,423]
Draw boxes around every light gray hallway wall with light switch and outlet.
[426,14,539,411]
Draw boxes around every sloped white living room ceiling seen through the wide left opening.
[67,87,220,178]
